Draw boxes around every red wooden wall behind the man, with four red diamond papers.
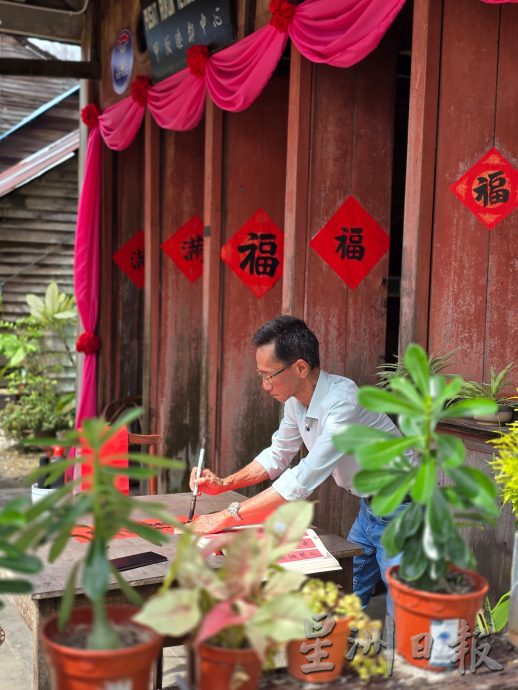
[99,1,404,532]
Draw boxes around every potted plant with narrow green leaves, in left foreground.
[14,410,185,690]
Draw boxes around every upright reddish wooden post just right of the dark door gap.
[399,0,443,353]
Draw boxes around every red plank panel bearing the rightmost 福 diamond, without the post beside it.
[414,0,518,380]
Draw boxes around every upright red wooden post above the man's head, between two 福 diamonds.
[282,44,312,318]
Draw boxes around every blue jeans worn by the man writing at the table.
[347,498,407,617]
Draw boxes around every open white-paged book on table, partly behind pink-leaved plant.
[198,525,342,575]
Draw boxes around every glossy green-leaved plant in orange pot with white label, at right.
[335,344,499,670]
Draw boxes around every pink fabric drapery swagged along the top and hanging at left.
[74,0,405,426]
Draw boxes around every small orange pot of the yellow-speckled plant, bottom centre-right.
[286,617,351,683]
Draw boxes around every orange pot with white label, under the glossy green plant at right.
[387,565,489,671]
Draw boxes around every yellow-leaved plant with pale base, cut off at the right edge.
[489,422,518,646]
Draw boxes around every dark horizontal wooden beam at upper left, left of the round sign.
[0,58,101,79]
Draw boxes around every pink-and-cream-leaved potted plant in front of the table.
[136,501,313,690]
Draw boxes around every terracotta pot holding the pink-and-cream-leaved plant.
[194,642,262,690]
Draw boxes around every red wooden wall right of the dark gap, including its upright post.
[400,0,518,600]
